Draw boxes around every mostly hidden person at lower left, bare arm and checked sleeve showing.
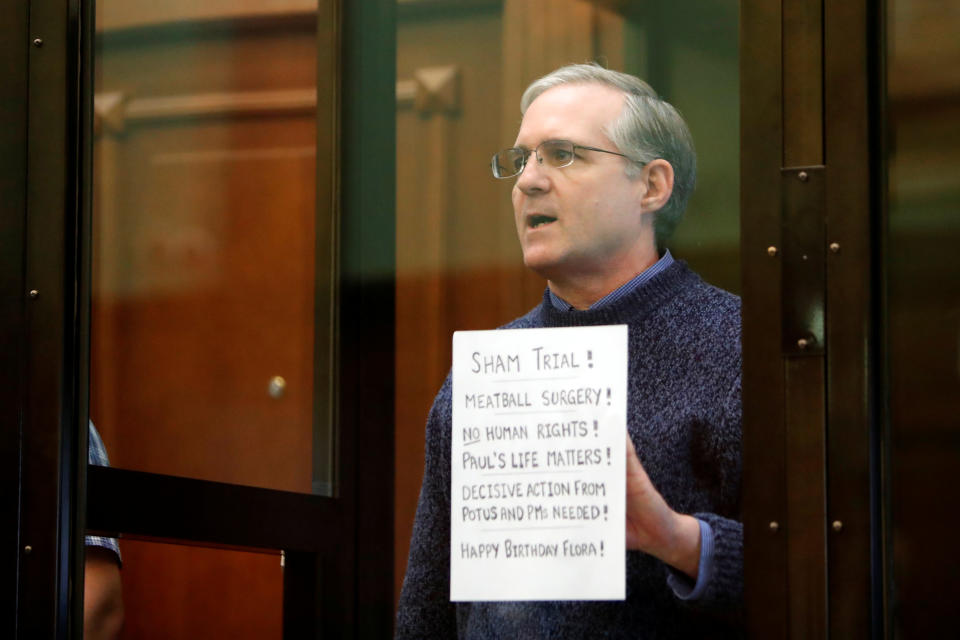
[83,422,123,640]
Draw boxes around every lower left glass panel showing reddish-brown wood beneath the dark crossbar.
[84,538,283,640]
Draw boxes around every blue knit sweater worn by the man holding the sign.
[397,262,743,639]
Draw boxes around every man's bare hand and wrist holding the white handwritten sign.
[627,434,700,580]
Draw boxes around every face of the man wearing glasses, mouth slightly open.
[513,84,653,282]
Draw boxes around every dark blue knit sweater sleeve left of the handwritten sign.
[396,377,456,638]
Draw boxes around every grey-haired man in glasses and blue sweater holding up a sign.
[397,65,742,638]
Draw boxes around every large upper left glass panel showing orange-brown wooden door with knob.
[90,0,336,494]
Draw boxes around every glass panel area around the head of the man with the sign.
[395,0,740,592]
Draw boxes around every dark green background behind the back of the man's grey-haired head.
[624,1,740,293]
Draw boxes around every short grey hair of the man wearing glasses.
[520,63,697,247]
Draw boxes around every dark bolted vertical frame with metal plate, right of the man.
[741,0,884,638]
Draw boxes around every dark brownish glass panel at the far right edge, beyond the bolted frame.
[886,0,960,638]
